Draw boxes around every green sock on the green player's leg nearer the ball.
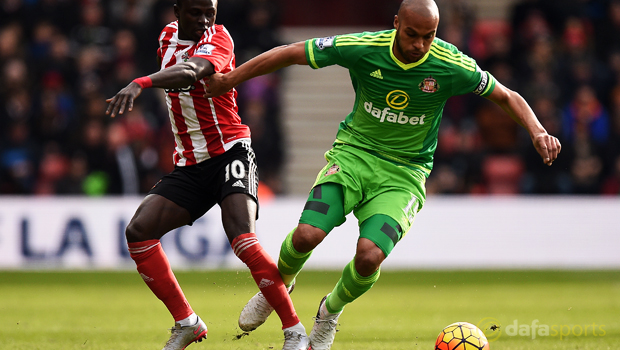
[325,259,381,314]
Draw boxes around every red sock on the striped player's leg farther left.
[128,239,194,321]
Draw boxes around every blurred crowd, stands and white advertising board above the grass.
[0,0,620,268]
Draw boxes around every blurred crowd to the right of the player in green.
[427,0,620,195]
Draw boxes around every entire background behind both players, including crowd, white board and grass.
[0,0,620,350]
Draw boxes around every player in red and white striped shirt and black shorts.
[106,0,308,350]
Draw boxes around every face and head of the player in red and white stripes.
[174,0,217,42]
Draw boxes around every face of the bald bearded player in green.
[393,11,439,64]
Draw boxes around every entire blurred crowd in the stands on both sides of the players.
[0,0,620,196]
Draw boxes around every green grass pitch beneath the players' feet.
[0,270,620,350]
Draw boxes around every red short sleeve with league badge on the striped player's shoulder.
[192,30,233,72]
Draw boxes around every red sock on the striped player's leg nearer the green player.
[231,233,299,329]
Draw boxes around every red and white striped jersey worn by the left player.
[157,21,250,166]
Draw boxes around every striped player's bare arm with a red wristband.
[105,57,214,118]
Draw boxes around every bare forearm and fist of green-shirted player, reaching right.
[486,82,562,165]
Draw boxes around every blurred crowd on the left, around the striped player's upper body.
[0,0,283,196]
